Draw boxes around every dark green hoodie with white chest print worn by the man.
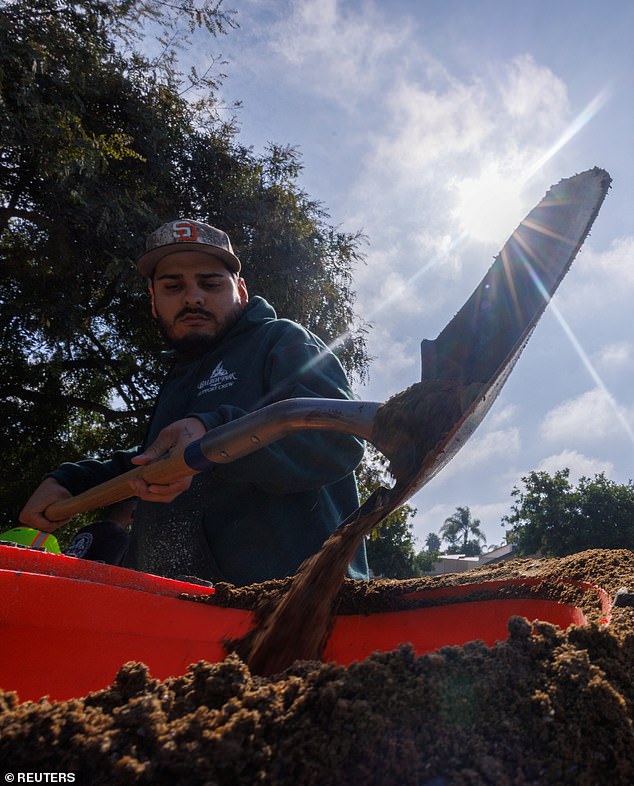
[52,297,367,585]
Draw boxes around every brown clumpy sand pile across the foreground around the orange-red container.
[0,551,634,786]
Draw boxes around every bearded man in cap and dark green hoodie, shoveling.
[20,219,367,585]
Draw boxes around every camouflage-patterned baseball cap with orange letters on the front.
[136,218,240,278]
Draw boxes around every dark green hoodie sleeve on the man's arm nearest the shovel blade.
[190,323,364,494]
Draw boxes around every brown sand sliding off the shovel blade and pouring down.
[239,380,482,676]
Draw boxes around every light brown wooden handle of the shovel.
[44,451,196,521]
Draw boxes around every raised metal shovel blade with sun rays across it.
[403,167,611,497]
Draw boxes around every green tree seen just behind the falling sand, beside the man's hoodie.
[357,446,419,579]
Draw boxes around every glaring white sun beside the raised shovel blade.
[453,163,525,245]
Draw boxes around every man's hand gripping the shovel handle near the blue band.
[130,418,206,502]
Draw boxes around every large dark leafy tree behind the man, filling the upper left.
[0,0,367,521]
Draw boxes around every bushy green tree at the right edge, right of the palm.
[502,469,634,557]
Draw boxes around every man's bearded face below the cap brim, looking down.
[150,251,249,352]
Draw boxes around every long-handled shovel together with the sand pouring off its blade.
[46,168,611,674]
